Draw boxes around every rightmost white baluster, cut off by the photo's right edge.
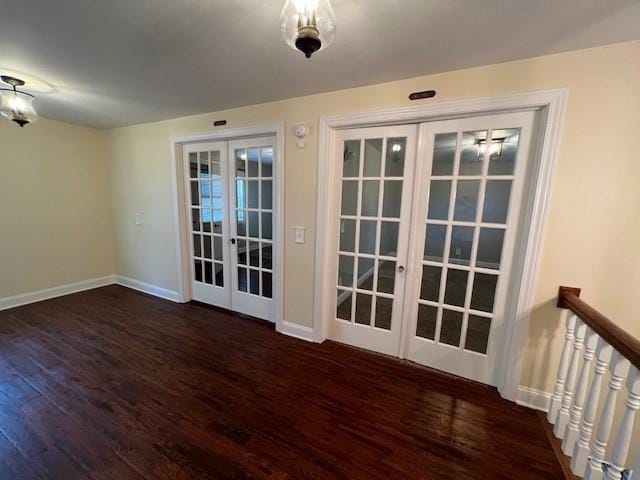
[606,367,640,480]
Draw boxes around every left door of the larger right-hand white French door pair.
[331,125,417,355]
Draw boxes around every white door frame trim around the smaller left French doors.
[169,122,285,331]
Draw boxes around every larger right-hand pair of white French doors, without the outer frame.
[330,112,534,385]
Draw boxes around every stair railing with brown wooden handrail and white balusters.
[547,287,640,480]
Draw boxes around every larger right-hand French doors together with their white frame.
[314,91,565,400]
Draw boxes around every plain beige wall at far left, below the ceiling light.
[0,119,115,298]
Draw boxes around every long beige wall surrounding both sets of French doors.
[107,42,640,391]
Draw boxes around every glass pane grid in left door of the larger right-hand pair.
[336,138,406,330]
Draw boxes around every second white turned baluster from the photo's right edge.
[584,351,629,480]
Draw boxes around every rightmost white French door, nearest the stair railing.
[405,112,534,385]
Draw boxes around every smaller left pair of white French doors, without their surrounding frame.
[183,137,276,321]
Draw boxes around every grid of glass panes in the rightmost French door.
[414,128,520,354]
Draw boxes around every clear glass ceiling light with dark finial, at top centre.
[280,0,336,58]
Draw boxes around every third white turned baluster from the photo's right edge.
[571,338,613,477]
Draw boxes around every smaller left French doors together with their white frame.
[171,125,283,329]
